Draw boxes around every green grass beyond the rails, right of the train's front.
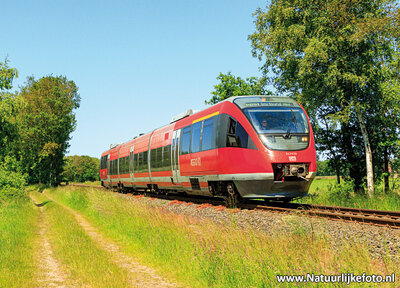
[295,177,400,211]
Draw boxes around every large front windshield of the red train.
[244,107,309,150]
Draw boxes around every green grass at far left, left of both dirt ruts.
[0,200,38,287]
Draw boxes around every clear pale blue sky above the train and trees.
[0,0,267,157]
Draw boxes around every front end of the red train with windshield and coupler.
[233,97,316,201]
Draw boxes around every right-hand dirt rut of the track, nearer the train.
[43,191,184,288]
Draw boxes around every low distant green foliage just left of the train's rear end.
[61,155,100,182]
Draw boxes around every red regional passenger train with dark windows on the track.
[100,96,316,206]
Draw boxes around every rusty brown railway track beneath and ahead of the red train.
[66,184,400,229]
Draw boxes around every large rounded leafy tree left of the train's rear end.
[16,76,80,184]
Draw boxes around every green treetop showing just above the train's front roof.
[206,72,272,105]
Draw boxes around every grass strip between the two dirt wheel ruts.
[31,192,130,287]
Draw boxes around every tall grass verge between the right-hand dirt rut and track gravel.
[50,187,400,287]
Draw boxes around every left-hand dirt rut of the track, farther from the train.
[32,198,78,287]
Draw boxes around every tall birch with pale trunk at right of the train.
[249,0,400,197]
